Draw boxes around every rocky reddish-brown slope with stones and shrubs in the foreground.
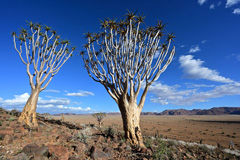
[0,108,240,160]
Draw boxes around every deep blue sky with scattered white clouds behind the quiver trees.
[0,0,240,113]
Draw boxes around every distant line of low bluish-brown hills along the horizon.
[53,107,240,116]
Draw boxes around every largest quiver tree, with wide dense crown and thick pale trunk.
[80,12,175,146]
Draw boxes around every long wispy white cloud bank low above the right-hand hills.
[149,82,240,105]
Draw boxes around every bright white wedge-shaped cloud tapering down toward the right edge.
[179,55,234,83]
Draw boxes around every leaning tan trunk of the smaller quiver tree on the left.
[18,87,40,127]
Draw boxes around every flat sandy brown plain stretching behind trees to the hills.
[52,115,240,150]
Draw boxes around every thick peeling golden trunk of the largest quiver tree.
[119,103,145,147]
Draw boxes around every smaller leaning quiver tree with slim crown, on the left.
[12,22,75,127]
